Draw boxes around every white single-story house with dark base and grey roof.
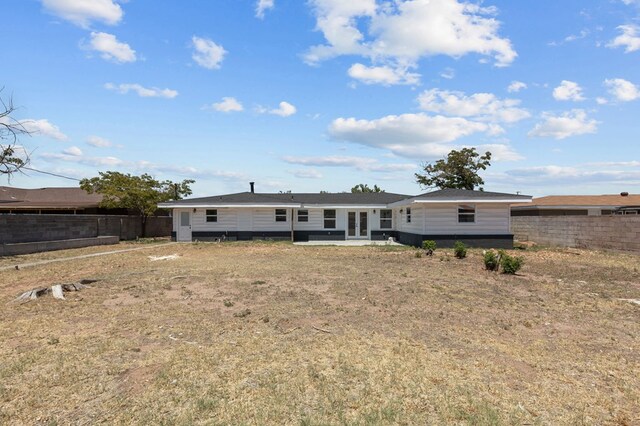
[159,185,531,248]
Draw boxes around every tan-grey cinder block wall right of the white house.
[511,215,640,252]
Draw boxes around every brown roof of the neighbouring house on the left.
[0,186,102,210]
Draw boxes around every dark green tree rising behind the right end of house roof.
[415,148,491,191]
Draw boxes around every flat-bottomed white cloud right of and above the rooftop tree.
[528,109,598,139]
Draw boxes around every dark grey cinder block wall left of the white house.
[0,215,173,244]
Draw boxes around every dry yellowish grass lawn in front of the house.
[0,242,640,425]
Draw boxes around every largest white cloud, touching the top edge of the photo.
[304,0,517,70]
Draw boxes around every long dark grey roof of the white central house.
[160,189,531,208]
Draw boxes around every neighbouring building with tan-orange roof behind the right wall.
[511,192,640,216]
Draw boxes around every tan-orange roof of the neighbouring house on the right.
[512,194,640,210]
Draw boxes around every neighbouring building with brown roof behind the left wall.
[0,186,127,215]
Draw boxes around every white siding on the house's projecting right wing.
[424,203,510,235]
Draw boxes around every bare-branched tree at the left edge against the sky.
[0,88,30,178]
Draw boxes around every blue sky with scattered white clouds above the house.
[0,0,640,196]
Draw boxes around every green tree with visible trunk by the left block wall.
[80,171,195,235]
